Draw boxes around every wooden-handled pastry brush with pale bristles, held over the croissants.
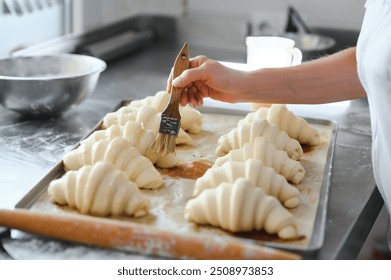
[154,43,189,155]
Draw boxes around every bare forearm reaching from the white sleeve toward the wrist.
[239,48,366,104]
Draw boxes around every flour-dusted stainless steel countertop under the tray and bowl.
[0,42,383,259]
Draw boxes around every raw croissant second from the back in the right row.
[216,119,303,160]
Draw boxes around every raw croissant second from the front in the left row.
[63,137,163,189]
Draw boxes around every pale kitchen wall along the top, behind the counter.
[74,0,365,31]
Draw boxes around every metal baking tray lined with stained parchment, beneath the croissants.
[16,100,337,258]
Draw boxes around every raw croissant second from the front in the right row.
[193,159,300,208]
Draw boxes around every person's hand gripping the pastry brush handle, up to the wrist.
[167,56,250,107]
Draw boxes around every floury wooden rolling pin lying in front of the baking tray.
[0,209,301,260]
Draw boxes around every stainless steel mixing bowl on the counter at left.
[0,54,106,117]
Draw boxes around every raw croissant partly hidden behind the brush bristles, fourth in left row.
[102,104,191,145]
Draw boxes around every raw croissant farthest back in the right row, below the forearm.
[239,104,320,145]
